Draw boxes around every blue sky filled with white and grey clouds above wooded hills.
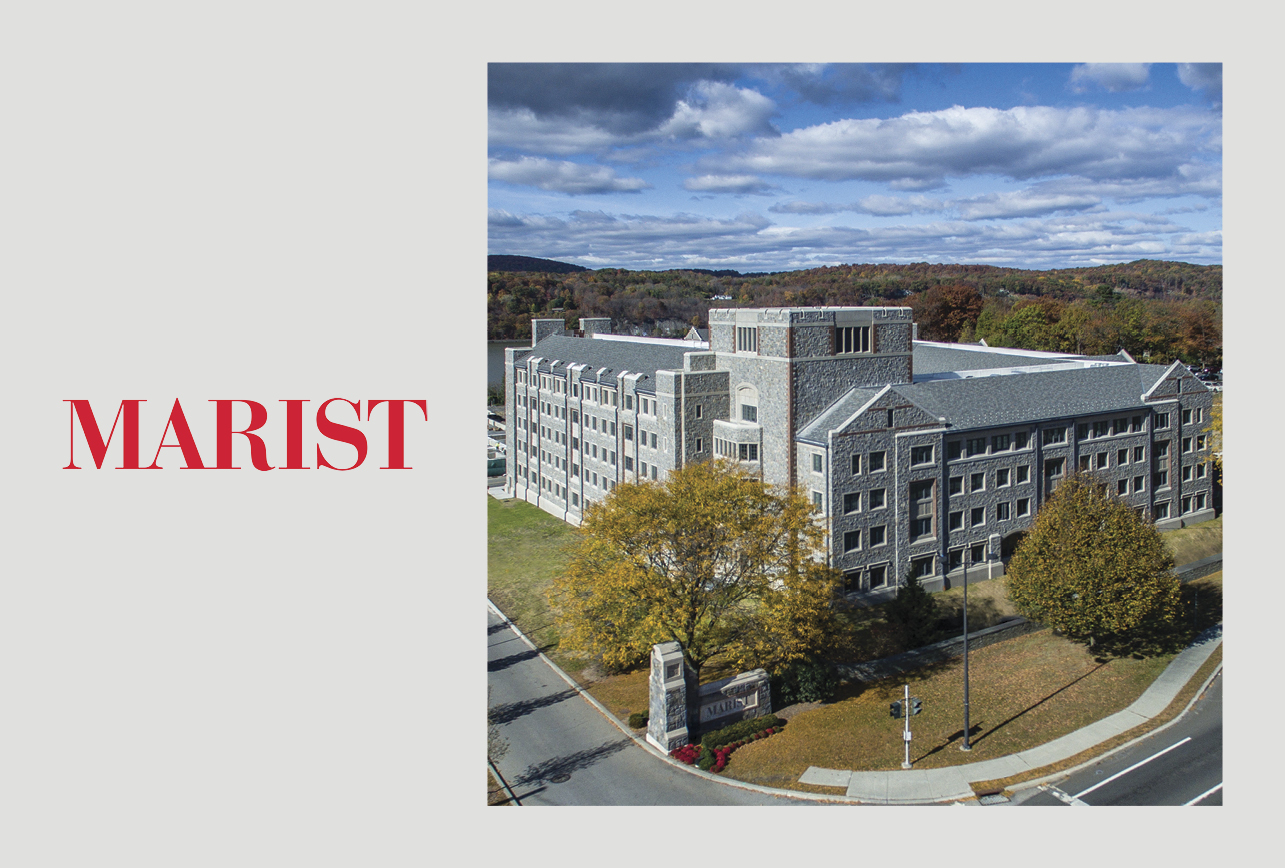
[487,63,1222,271]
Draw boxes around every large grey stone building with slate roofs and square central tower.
[505,307,1214,593]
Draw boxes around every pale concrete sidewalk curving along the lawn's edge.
[799,625,1222,805]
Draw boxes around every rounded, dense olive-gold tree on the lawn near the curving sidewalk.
[1005,475,1178,647]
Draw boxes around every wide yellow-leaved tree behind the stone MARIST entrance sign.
[549,460,838,676]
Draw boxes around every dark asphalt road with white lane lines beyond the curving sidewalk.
[1014,676,1222,806]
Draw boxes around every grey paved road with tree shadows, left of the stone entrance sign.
[487,610,810,806]
